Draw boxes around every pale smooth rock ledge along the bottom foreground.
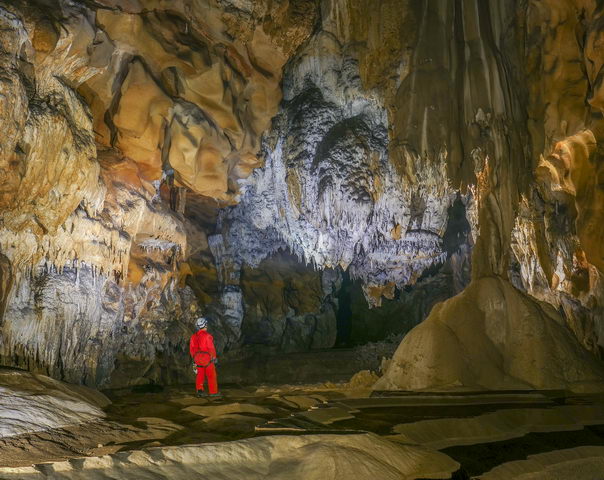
[2,434,459,480]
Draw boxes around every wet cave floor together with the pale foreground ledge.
[0,374,604,479]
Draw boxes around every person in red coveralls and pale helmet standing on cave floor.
[189,317,221,397]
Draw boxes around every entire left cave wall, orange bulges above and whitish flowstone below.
[0,1,316,385]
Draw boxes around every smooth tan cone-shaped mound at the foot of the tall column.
[374,277,604,391]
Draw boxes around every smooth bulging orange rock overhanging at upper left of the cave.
[89,2,314,200]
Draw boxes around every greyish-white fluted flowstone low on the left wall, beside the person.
[0,266,201,386]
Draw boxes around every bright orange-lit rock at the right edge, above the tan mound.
[512,130,604,357]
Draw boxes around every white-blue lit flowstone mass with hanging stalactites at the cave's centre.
[221,9,454,316]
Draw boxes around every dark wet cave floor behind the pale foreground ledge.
[0,384,604,479]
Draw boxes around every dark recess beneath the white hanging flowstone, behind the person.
[182,194,472,368]
